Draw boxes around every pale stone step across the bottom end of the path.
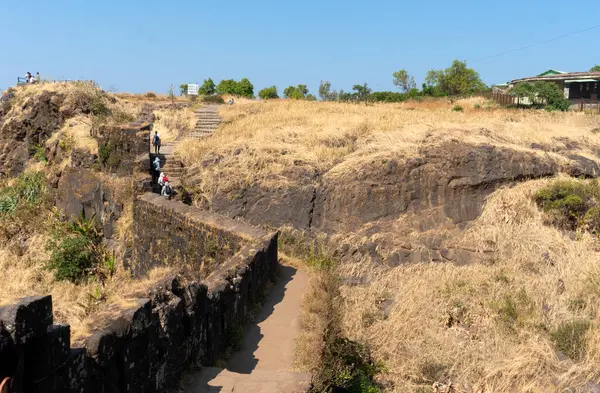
[183,367,311,393]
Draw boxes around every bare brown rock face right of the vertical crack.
[313,143,558,232]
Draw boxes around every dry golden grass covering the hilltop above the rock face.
[178,99,600,200]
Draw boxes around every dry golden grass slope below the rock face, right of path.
[342,180,600,393]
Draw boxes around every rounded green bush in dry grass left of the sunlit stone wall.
[47,234,96,282]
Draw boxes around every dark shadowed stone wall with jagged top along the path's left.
[0,230,277,393]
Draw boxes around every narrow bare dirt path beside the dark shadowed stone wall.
[184,266,310,393]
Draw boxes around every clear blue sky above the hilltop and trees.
[0,0,600,93]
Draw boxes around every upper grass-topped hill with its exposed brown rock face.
[181,102,600,266]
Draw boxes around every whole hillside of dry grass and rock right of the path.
[173,100,600,393]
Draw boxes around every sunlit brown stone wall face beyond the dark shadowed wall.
[131,193,264,277]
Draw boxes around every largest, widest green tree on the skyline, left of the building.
[425,60,486,95]
